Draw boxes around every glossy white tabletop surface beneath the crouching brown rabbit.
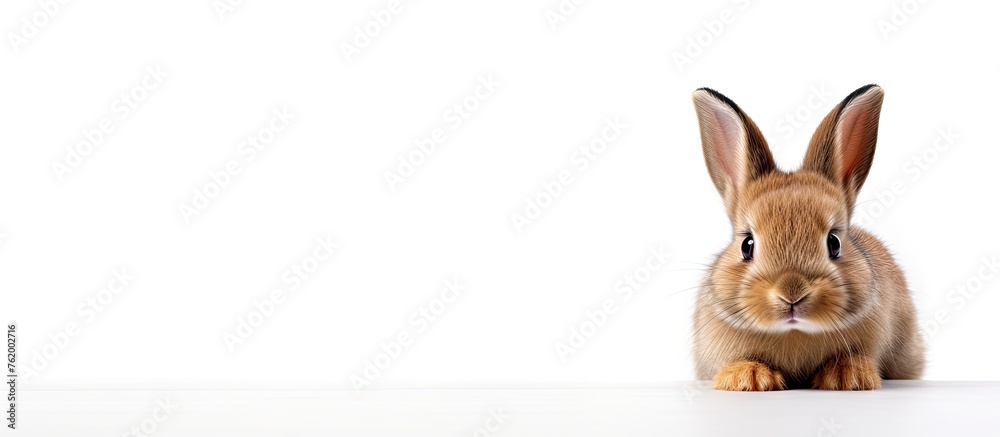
[19,381,1000,437]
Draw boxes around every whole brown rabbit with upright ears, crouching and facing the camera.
[692,85,924,391]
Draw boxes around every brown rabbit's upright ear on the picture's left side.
[692,88,777,207]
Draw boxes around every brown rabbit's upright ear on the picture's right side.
[802,85,883,206]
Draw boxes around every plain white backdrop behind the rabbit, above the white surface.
[0,0,1000,387]
